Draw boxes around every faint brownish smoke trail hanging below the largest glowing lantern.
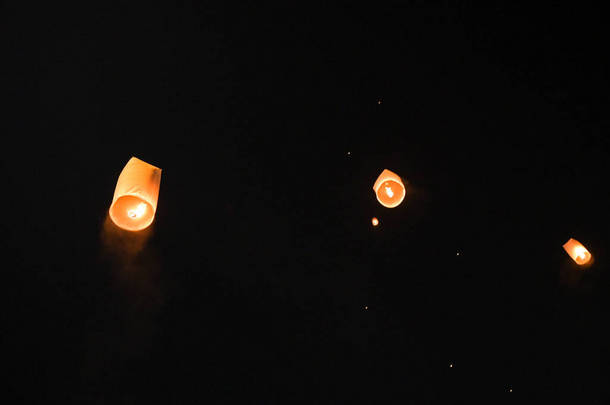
[81,216,165,392]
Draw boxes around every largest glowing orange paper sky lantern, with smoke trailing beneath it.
[109,157,161,231]
